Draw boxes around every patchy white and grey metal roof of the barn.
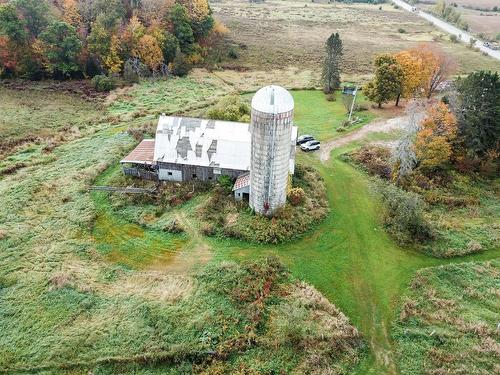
[154,115,297,171]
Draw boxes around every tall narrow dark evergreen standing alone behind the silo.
[323,33,344,94]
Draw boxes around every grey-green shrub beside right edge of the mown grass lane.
[377,183,433,244]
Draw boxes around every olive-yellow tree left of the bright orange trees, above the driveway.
[365,54,404,108]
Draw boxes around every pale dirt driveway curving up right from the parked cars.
[320,116,407,162]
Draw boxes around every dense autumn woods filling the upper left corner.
[0,0,227,79]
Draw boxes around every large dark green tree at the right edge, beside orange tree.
[454,71,500,157]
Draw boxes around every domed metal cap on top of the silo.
[252,85,294,113]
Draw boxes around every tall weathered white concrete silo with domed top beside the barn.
[249,86,294,216]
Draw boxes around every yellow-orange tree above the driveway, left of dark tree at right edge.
[415,103,457,170]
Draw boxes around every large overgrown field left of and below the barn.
[0,79,368,373]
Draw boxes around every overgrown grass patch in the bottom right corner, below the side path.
[392,261,500,375]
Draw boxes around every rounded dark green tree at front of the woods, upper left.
[40,21,82,77]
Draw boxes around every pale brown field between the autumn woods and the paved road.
[212,0,498,77]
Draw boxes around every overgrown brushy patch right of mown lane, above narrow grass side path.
[348,145,500,258]
